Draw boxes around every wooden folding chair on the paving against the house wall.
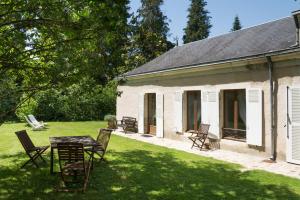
[188,124,210,150]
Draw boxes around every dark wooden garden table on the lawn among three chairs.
[49,135,98,174]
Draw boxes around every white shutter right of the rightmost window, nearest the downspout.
[246,88,262,146]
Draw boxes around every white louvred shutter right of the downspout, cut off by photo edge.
[287,87,300,164]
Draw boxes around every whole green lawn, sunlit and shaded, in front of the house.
[0,122,300,200]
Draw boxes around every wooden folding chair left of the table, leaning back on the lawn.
[16,130,49,168]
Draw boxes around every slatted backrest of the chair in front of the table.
[57,142,85,170]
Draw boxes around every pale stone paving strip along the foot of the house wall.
[113,130,300,179]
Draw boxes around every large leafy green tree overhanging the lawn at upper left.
[0,0,129,122]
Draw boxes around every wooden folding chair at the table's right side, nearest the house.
[85,128,113,167]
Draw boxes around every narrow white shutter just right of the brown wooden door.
[156,93,164,138]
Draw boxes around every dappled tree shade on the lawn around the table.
[0,150,300,200]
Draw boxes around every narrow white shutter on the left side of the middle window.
[174,91,183,133]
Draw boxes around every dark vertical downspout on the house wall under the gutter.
[266,56,276,161]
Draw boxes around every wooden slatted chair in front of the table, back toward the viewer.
[57,142,91,192]
